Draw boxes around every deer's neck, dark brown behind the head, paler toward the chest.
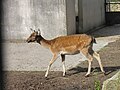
[36,36,51,48]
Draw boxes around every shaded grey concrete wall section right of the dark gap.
[78,0,105,33]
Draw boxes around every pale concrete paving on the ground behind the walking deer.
[3,26,120,71]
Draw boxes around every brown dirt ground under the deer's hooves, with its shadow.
[3,40,120,90]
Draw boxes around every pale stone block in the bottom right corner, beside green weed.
[102,70,120,90]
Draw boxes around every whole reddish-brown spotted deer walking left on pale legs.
[26,28,105,77]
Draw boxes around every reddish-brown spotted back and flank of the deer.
[51,34,92,51]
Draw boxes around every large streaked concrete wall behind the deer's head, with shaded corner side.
[2,0,75,39]
